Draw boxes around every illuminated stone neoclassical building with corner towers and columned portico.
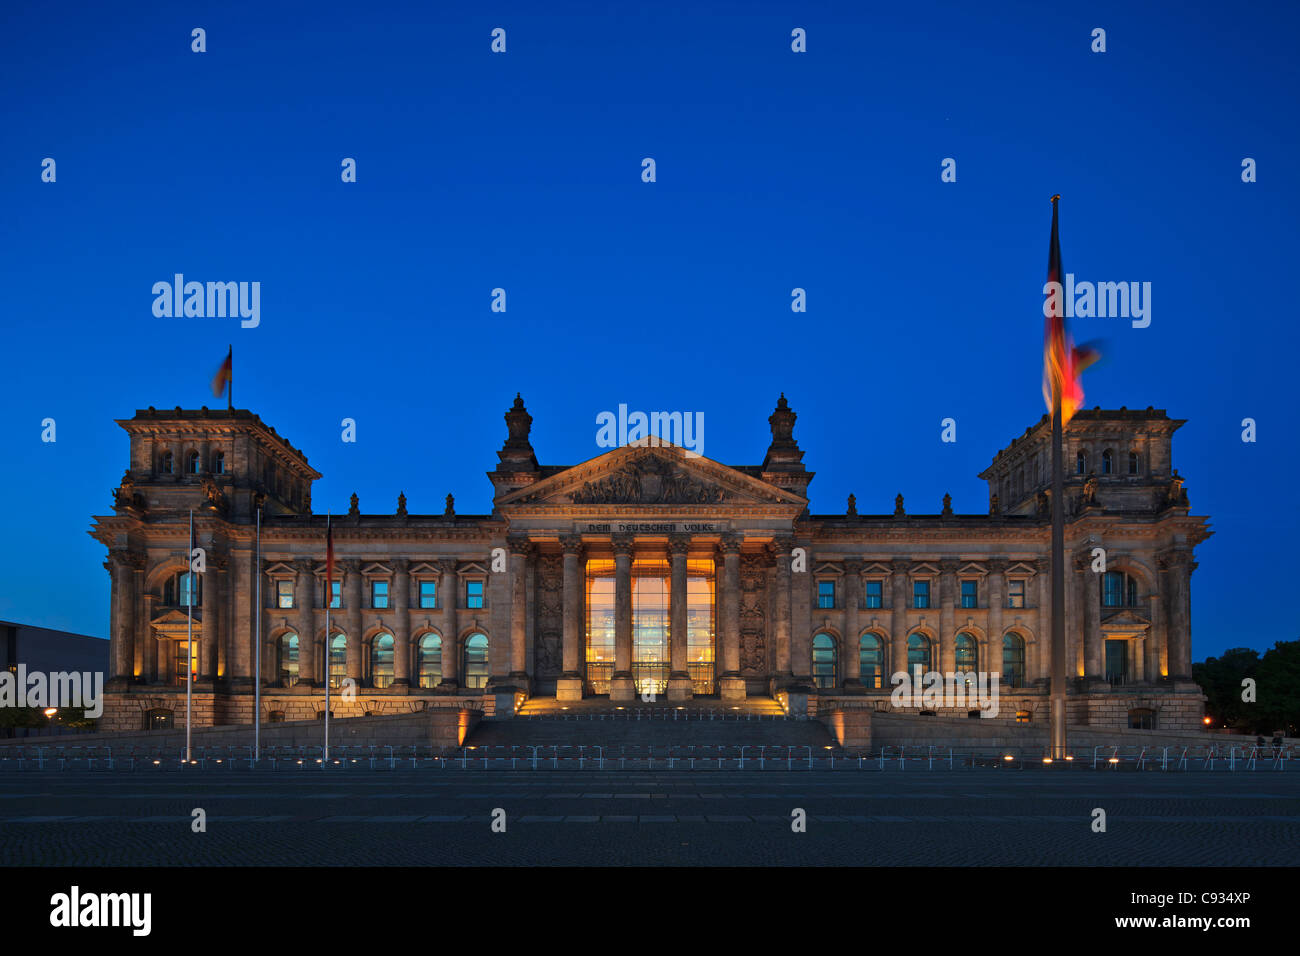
[91,395,1210,731]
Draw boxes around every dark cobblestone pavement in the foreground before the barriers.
[0,770,1300,866]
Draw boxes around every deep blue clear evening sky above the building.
[0,1,1300,659]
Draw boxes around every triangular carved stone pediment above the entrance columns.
[497,445,807,511]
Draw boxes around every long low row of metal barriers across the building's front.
[0,744,1297,773]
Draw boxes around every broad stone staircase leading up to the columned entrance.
[465,697,839,758]
